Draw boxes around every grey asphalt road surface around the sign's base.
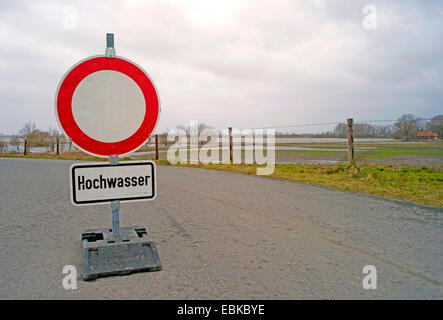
[0,158,443,299]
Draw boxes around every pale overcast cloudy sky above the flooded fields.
[0,0,443,134]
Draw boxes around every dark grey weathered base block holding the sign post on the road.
[82,227,162,280]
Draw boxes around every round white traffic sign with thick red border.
[55,56,160,157]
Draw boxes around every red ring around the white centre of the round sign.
[57,57,159,156]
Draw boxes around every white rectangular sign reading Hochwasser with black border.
[70,161,156,205]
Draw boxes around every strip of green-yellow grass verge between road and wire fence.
[158,160,443,207]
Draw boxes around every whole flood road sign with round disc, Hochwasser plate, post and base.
[59,33,161,280]
